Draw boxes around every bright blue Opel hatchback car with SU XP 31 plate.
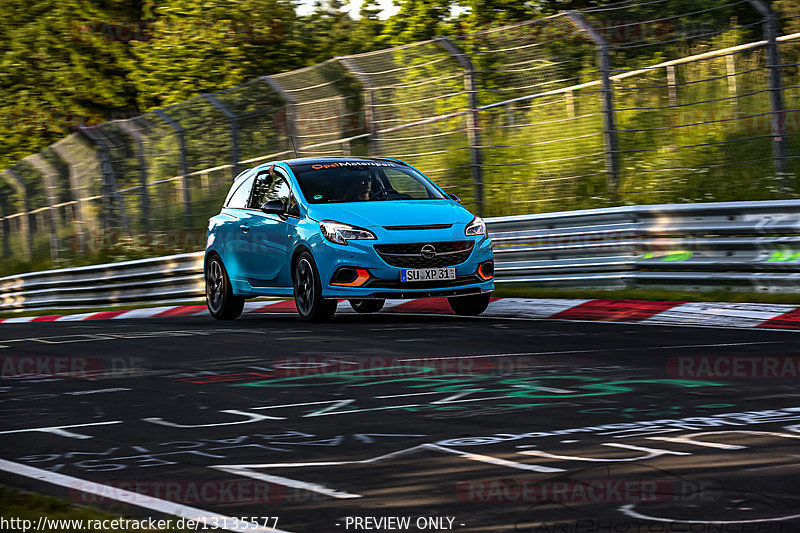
[205,157,494,321]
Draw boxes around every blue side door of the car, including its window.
[240,171,291,287]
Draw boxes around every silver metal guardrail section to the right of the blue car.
[489,200,800,292]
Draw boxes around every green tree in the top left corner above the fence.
[0,0,142,168]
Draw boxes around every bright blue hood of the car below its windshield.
[309,200,474,228]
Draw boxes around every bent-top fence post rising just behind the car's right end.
[436,37,484,216]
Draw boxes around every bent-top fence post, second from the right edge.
[567,11,619,202]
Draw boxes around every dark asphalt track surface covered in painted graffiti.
[0,314,800,533]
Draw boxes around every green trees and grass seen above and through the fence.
[0,0,800,272]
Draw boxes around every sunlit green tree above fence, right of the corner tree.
[127,0,306,109]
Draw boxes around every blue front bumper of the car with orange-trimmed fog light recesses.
[314,236,494,299]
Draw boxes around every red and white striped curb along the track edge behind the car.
[0,298,800,330]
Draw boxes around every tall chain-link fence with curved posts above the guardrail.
[0,0,800,273]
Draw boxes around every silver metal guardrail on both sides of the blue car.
[0,200,800,311]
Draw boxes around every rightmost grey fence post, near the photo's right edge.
[749,0,792,190]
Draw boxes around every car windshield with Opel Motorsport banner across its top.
[292,161,446,204]
